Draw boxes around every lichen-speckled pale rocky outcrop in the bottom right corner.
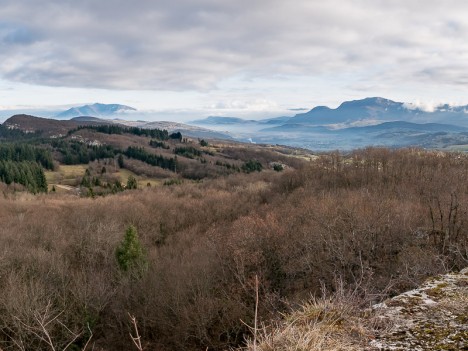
[371,268,468,351]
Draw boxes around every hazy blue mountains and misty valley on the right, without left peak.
[187,97,468,150]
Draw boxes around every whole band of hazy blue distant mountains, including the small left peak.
[5,97,468,150]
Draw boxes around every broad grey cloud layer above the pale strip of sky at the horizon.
[0,0,468,90]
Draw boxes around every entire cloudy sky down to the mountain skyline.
[0,0,468,121]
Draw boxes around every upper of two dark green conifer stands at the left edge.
[0,143,54,169]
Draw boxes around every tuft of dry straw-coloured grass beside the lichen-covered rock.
[239,294,375,351]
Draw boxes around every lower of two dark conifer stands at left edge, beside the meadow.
[0,159,47,193]
